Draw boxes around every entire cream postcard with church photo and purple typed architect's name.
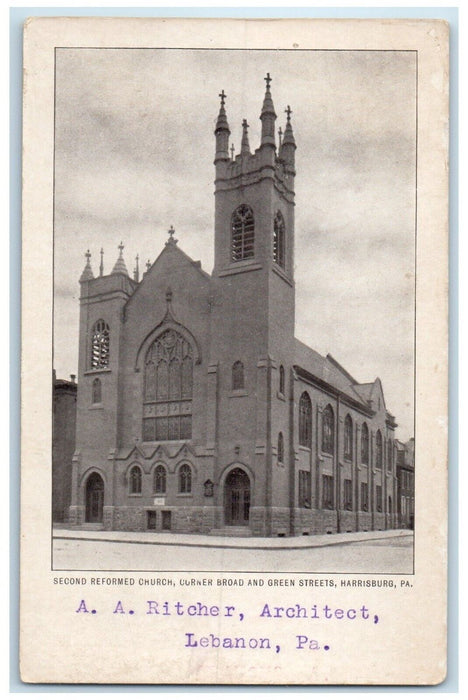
[20,17,449,686]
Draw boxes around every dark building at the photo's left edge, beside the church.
[52,370,77,522]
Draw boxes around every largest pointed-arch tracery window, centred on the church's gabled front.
[143,330,193,442]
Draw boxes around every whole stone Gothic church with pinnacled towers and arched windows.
[69,75,397,537]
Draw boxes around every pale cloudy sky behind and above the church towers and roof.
[54,49,416,440]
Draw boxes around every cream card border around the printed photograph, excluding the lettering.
[20,18,448,684]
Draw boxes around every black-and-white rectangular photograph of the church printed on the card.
[52,46,418,574]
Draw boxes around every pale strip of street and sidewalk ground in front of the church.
[53,528,413,574]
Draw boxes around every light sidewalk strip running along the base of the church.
[53,525,413,550]
